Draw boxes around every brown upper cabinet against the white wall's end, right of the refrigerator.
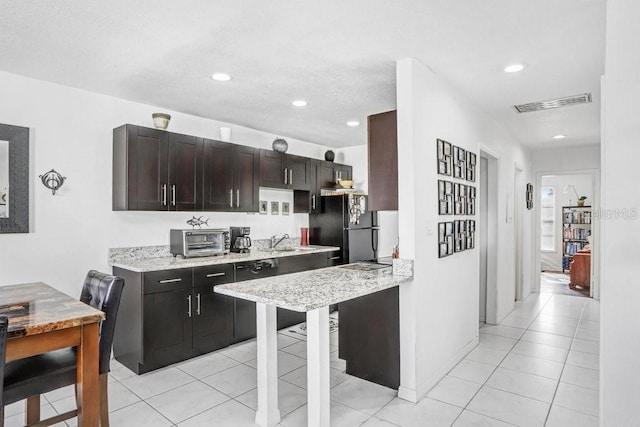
[367,110,398,211]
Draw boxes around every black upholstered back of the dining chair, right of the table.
[80,270,124,374]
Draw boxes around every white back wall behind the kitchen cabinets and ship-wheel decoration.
[0,73,344,295]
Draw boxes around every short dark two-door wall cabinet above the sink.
[260,150,311,190]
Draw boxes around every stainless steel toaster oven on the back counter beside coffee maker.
[169,228,231,258]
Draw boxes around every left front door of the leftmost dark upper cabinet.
[127,126,169,210]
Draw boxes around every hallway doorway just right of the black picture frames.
[477,147,499,325]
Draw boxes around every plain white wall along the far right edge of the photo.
[600,0,640,426]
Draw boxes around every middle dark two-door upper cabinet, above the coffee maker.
[203,139,260,212]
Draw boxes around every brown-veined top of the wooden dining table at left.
[0,283,104,338]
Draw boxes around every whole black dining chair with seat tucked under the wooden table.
[0,270,124,427]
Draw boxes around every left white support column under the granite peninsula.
[256,302,278,427]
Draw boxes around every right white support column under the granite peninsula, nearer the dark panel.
[307,306,330,427]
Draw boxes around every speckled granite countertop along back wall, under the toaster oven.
[112,246,340,272]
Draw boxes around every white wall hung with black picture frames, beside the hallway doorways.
[396,59,532,401]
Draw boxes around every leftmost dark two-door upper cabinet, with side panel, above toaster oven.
[113,125,202,211]
